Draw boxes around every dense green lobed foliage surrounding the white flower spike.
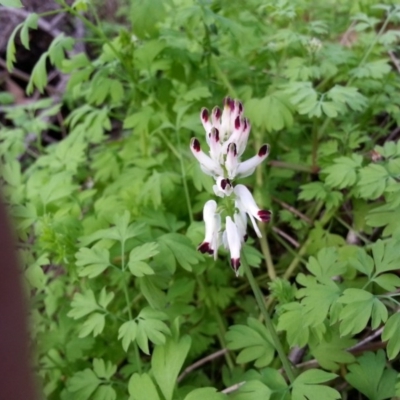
[0,0,400,400]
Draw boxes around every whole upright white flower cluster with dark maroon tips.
[190,97,271,275]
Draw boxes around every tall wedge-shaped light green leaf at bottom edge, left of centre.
[151,336,192,400]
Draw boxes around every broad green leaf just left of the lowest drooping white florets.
[155,233,203,273]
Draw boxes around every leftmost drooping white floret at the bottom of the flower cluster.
[198,200,221,259]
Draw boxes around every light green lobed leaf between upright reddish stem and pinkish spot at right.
[321,154,362,189]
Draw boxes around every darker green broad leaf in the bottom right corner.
[345,350,397,400]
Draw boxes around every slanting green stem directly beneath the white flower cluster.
[241,254,295,383]
